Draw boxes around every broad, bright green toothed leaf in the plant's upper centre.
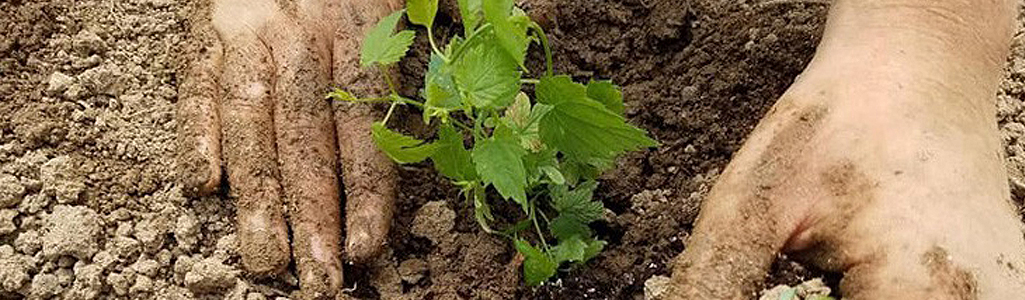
[453,35,520,109]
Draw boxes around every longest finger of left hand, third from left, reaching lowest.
[265,17,342,298]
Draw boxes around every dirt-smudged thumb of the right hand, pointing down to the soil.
[669,97,823,299]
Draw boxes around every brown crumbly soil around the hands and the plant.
[0,0,1025,300]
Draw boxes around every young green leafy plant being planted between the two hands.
[329,0,657,285]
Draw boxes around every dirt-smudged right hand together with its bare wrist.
[668,0,1025,300]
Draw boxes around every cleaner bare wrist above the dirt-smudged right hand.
[794,0,1016,110]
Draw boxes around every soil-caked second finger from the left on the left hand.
[213,0,290,275]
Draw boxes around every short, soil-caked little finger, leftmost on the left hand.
[177,2,223,196]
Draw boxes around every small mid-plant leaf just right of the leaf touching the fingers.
[431,121,477,181]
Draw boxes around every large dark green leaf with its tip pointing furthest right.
[536,76,658,163]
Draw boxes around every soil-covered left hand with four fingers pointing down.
[178,0,401,297]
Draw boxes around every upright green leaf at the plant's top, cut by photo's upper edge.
[482,0,530,67]
